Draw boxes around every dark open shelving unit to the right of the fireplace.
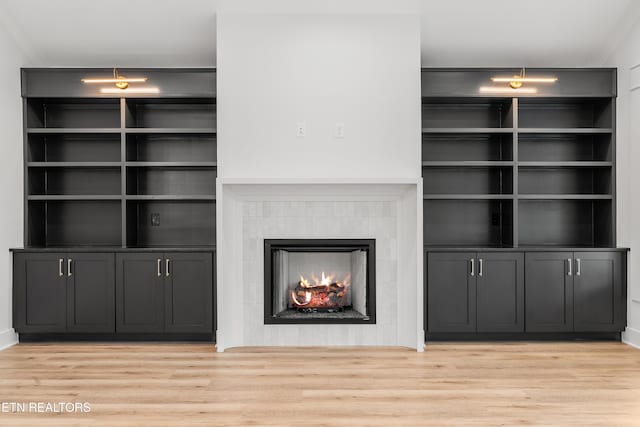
[422,69,615,248]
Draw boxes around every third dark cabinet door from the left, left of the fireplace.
[116,253,164,333]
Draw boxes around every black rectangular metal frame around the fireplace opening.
[263,239,376,325]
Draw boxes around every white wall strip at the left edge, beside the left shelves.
[0,20,23,349]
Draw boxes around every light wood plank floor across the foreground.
[0,343,640,426]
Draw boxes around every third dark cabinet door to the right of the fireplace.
[525,252,575,332]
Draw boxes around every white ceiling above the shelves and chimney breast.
[0,0,640,67]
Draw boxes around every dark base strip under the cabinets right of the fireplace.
[425,332,622,344]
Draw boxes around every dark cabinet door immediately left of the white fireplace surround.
[164,253,213,333]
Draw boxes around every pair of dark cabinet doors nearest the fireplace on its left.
[116,253,213,333]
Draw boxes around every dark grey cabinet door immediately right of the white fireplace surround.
[427,252,477,332]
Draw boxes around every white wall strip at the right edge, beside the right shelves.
[606,16,640,347]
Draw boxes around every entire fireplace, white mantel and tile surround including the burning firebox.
[217,182,424,351]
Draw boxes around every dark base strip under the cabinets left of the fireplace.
[20,333,215,344]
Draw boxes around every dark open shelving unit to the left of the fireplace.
[23,69,217,248]
